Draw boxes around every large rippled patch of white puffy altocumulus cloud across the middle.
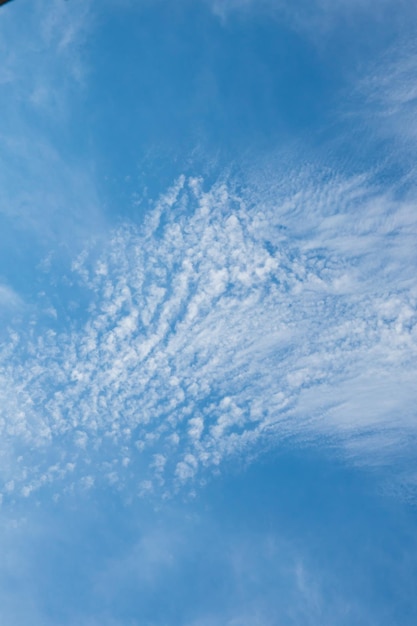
[0,172,417,497]
